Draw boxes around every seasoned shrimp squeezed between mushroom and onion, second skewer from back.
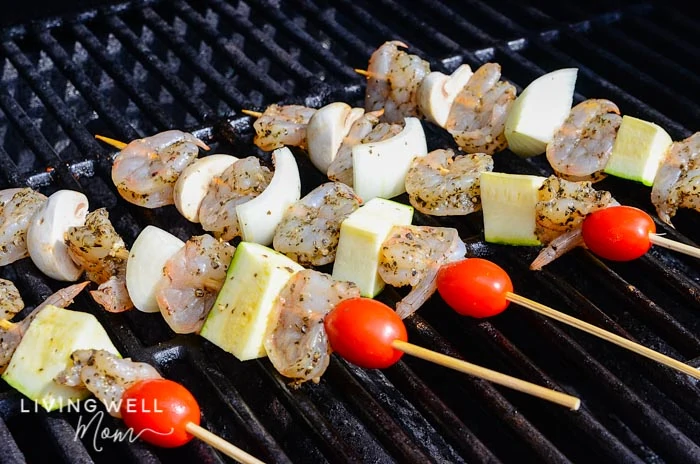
[327,110,396,187]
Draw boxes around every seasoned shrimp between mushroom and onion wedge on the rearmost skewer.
[445,63,516,155]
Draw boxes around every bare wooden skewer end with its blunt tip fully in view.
[391,340,581,411]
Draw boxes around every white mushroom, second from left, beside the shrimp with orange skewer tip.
[173,155,238,222]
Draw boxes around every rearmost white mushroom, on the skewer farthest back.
[418,64,474,127]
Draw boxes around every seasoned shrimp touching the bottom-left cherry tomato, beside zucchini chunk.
[55,349,162,418]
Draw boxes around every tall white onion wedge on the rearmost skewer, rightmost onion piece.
[505,68,578,157]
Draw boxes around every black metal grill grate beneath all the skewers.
[0,0,700,463]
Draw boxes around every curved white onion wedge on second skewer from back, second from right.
[352,118,428,202]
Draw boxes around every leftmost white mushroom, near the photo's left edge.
[27,190,89,282]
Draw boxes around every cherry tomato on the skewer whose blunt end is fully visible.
[323,298,408,369]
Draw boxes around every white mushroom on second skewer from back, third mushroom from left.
[306,102,365,174]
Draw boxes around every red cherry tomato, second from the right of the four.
[437,258,513,318]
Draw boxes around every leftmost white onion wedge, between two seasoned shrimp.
[126,226,185,313]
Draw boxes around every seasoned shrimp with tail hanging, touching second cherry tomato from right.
[379,226,467,319]
